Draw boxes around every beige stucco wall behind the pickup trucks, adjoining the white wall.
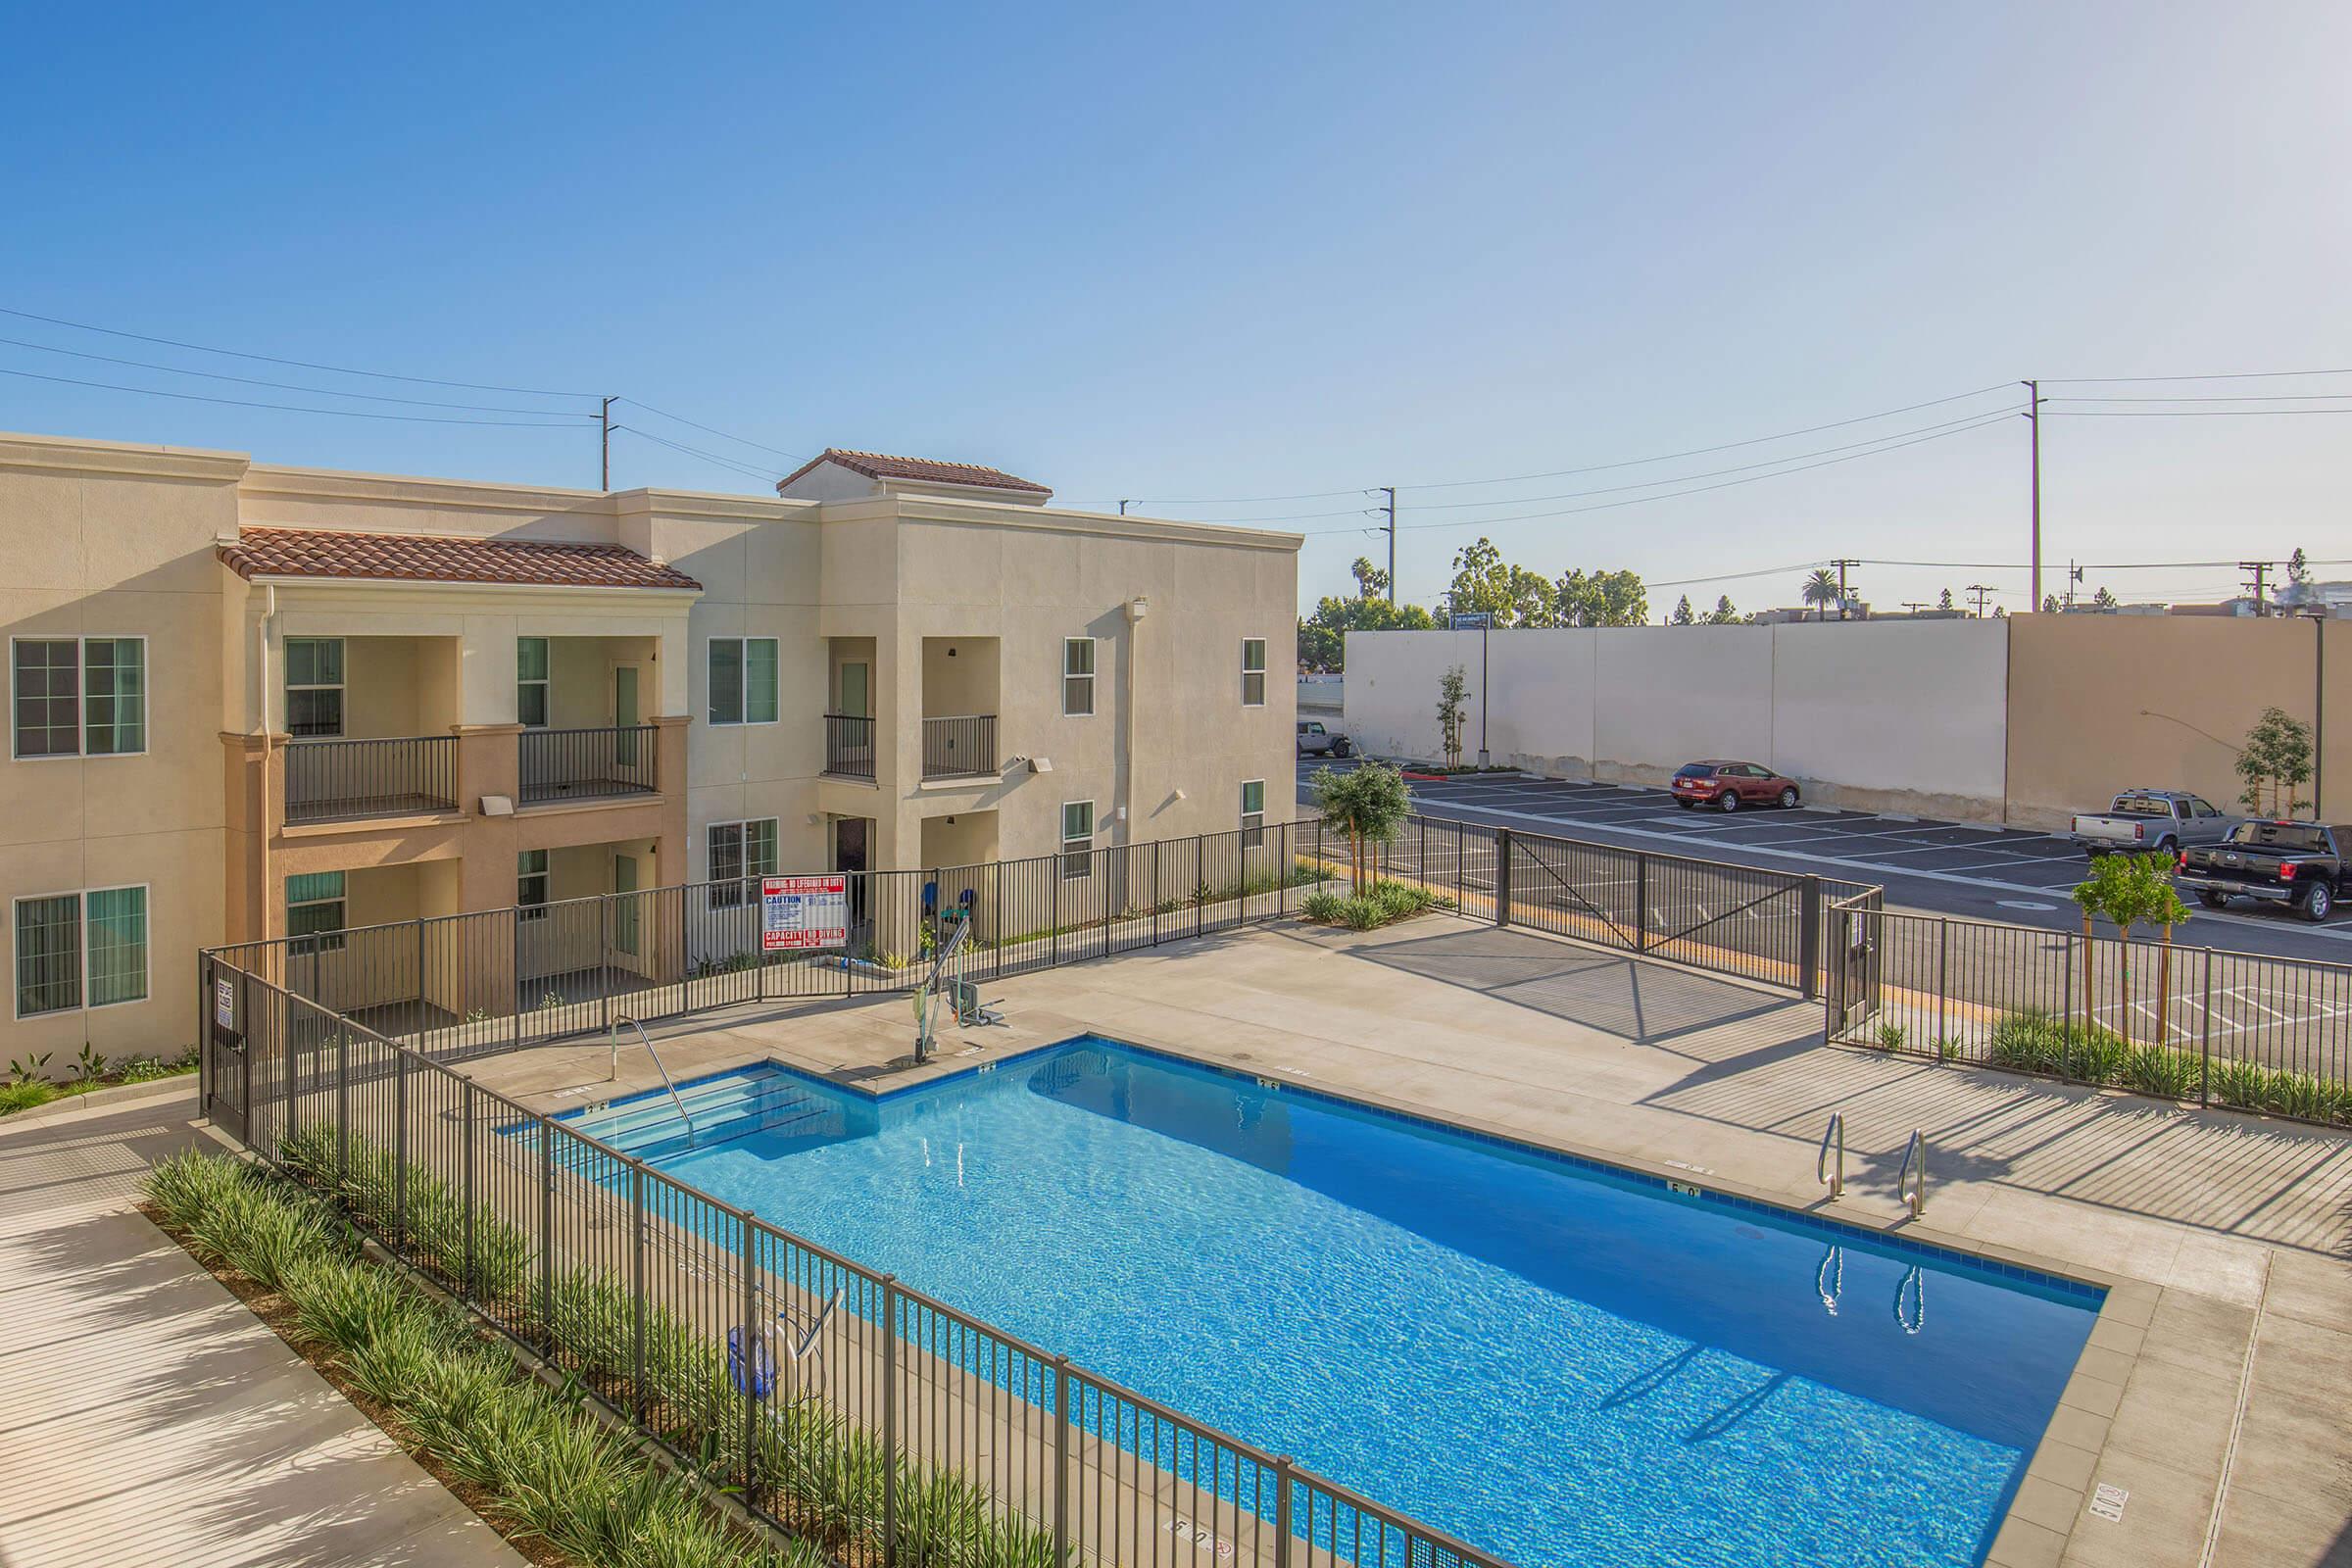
[2009,615,2324,825]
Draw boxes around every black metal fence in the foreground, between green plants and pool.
[205,953,1498,1568]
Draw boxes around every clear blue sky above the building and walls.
[0,5,2352,613]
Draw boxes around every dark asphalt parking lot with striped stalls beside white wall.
[1298,757,2352,961]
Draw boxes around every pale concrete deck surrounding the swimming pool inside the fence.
[464,917,2352,1568]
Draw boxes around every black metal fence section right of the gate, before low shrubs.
[1828,896,2352,1124]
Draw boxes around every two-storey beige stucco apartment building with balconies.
[0,435,1298,1069]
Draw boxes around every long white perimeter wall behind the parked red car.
[1346,620,2009,820]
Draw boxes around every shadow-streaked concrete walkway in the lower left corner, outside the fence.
[0,1079,522,1568]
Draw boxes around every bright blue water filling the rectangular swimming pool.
[560,1039,2100,1568]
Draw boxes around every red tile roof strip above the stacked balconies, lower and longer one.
[221,529,701,588]
